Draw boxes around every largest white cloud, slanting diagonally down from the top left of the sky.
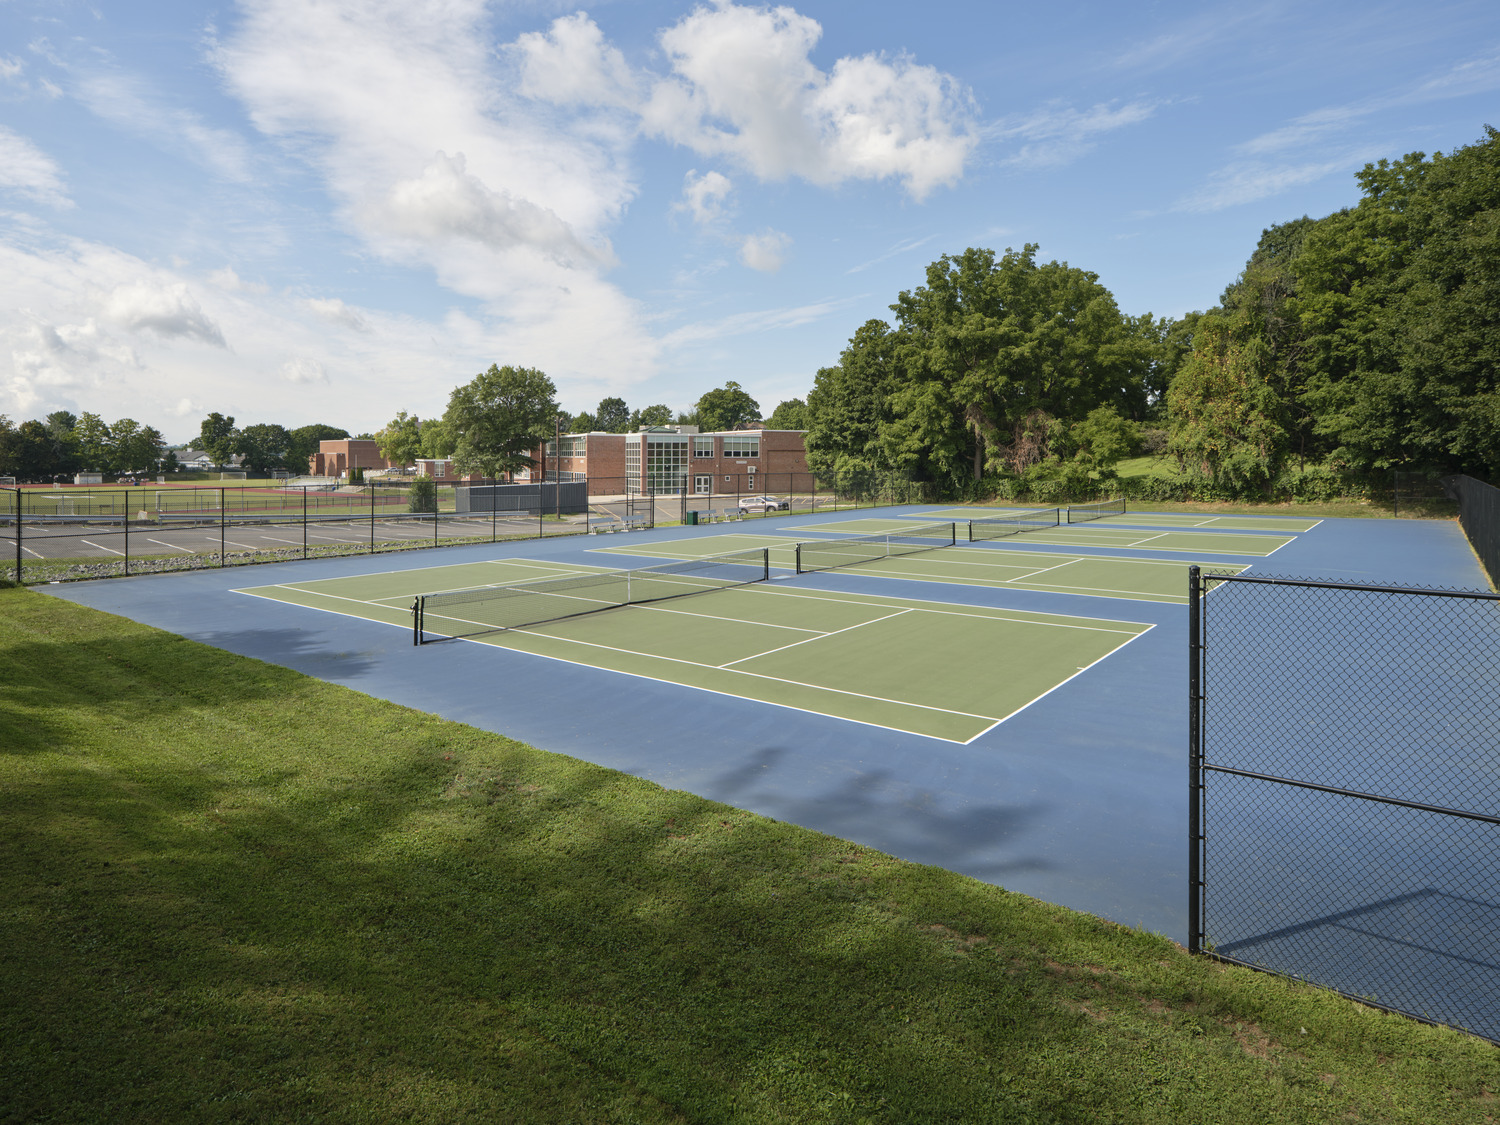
[215,0,657,390]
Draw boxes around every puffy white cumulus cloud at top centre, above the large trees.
[642,3,978,200]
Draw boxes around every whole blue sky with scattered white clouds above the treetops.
[0,0,1500,441]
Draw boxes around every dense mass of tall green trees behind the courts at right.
[798,126,1500,500]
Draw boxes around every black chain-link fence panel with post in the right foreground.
[1188,567,1500,1043]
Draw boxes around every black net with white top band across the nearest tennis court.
[411,548,771,645]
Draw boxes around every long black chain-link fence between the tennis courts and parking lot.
[0,473,932,584]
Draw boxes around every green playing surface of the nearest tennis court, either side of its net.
[236,567,1152,743]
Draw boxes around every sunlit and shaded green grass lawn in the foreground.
[0,590,1500,1125]
